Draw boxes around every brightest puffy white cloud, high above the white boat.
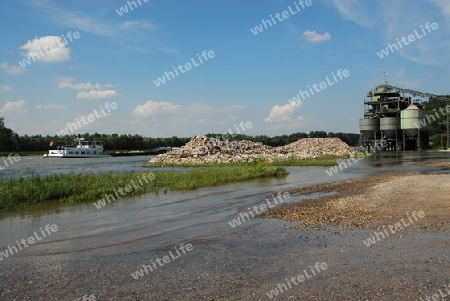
[20,36,70,63]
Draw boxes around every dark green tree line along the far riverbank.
[0,117,359,152]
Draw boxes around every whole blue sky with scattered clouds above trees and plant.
[0,0,450,137]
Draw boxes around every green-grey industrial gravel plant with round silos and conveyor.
[359,82,450,151]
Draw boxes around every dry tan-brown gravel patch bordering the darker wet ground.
[260,171,450,229]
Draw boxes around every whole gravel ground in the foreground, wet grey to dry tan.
[0,175,450,300]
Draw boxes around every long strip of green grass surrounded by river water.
[0,166,288,211]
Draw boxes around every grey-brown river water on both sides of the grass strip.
[0,152,450,257]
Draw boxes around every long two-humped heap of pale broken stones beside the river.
[149,136,354,165]
